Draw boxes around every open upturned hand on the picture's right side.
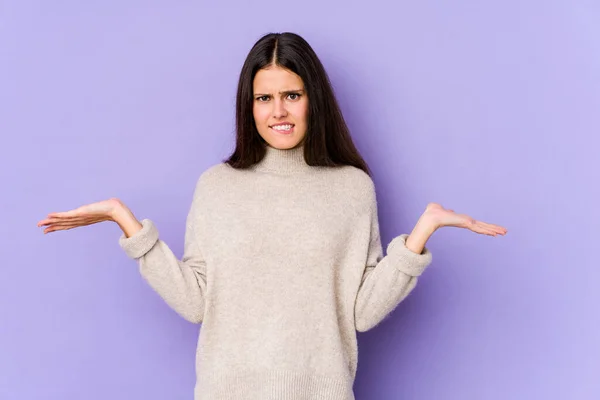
[423,203,507,236]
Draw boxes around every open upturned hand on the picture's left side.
[37,198,125,234]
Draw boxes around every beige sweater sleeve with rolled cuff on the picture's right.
[355,189,432,332]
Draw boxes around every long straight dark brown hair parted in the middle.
[224,32,370,175]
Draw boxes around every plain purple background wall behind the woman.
[0,0,600,400]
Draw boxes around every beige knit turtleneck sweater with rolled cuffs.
[119,146,432,400]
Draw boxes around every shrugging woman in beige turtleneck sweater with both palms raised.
[38,33,506,400]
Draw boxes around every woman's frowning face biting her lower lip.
[252,65,308,149]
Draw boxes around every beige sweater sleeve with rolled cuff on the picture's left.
[119,180,206,323]
